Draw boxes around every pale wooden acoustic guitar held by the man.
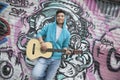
[26,39,81,60]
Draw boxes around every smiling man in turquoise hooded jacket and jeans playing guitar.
[32,10,71,80]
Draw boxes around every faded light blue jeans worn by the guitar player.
[32,58,61,80]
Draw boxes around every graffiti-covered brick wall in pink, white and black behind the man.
[0,0,120,80]
